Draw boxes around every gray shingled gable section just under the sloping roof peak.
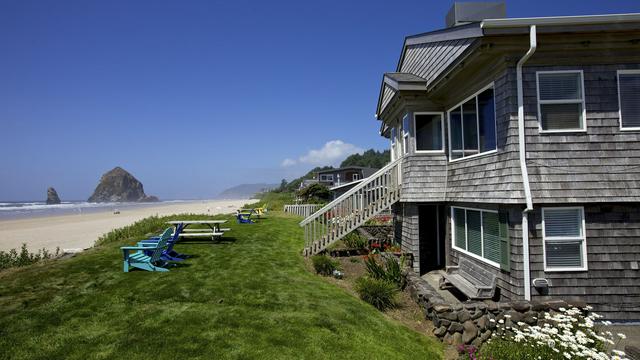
[398,39,475,84]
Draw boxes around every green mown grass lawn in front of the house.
[0,214,442,359]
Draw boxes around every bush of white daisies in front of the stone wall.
[476,307,625,360]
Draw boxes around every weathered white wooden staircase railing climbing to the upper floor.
[300,158,402,256]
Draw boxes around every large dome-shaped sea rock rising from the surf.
[89,166,159,202]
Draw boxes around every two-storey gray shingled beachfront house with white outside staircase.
[301,3,640,320]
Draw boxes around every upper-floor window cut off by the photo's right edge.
[618,70,640,130]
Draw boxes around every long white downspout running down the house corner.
[516,25,537,300]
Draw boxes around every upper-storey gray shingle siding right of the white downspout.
[524,65,640,203]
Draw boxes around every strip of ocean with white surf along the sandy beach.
[0,200,193,220]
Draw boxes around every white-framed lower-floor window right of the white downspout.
[542,207,587,271]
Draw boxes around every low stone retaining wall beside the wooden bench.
[407,271,586,346]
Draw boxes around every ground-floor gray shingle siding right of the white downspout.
[529,203,640,320]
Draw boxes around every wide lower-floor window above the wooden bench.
[451,207,511,270]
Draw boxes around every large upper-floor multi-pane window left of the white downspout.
[449,85,497,160]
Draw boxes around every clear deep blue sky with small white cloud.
[0,0,640,201]
